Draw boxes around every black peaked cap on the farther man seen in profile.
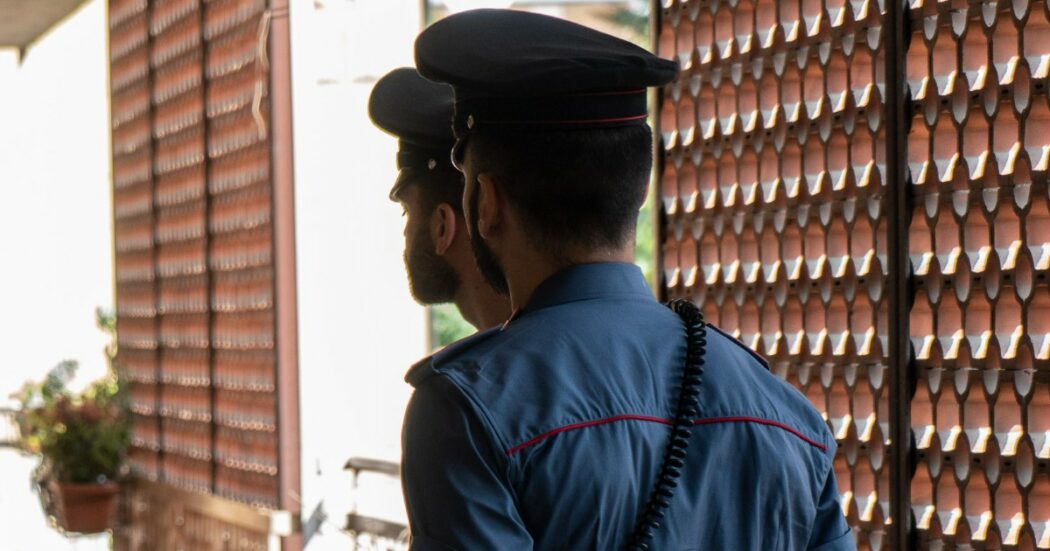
[369,67,455,198]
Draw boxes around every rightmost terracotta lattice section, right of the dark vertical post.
[906,0,1050,549]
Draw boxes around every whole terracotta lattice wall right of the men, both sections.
[657,0,1050,549]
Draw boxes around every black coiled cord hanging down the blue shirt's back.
[627,299,708,551]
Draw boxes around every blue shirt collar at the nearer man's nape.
[522,262,653,314]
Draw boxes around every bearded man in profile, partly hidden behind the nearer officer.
[369,67,510,329]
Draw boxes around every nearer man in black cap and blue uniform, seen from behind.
[402,10,855,551]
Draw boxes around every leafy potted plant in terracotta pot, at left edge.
[16,308,129,533]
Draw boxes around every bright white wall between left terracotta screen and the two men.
[291,0,426,549]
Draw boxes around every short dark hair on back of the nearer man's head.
[466,126,652,256]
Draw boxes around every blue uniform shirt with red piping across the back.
[402,263,855,551]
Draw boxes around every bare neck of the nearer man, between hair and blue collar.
[503,239,634,312]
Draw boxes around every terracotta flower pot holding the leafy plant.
[47,481,118,534]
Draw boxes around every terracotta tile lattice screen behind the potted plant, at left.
[109,0,289,516]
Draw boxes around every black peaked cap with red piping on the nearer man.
[416,9,678,135]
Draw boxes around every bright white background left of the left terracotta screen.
[0,0,113,403]
